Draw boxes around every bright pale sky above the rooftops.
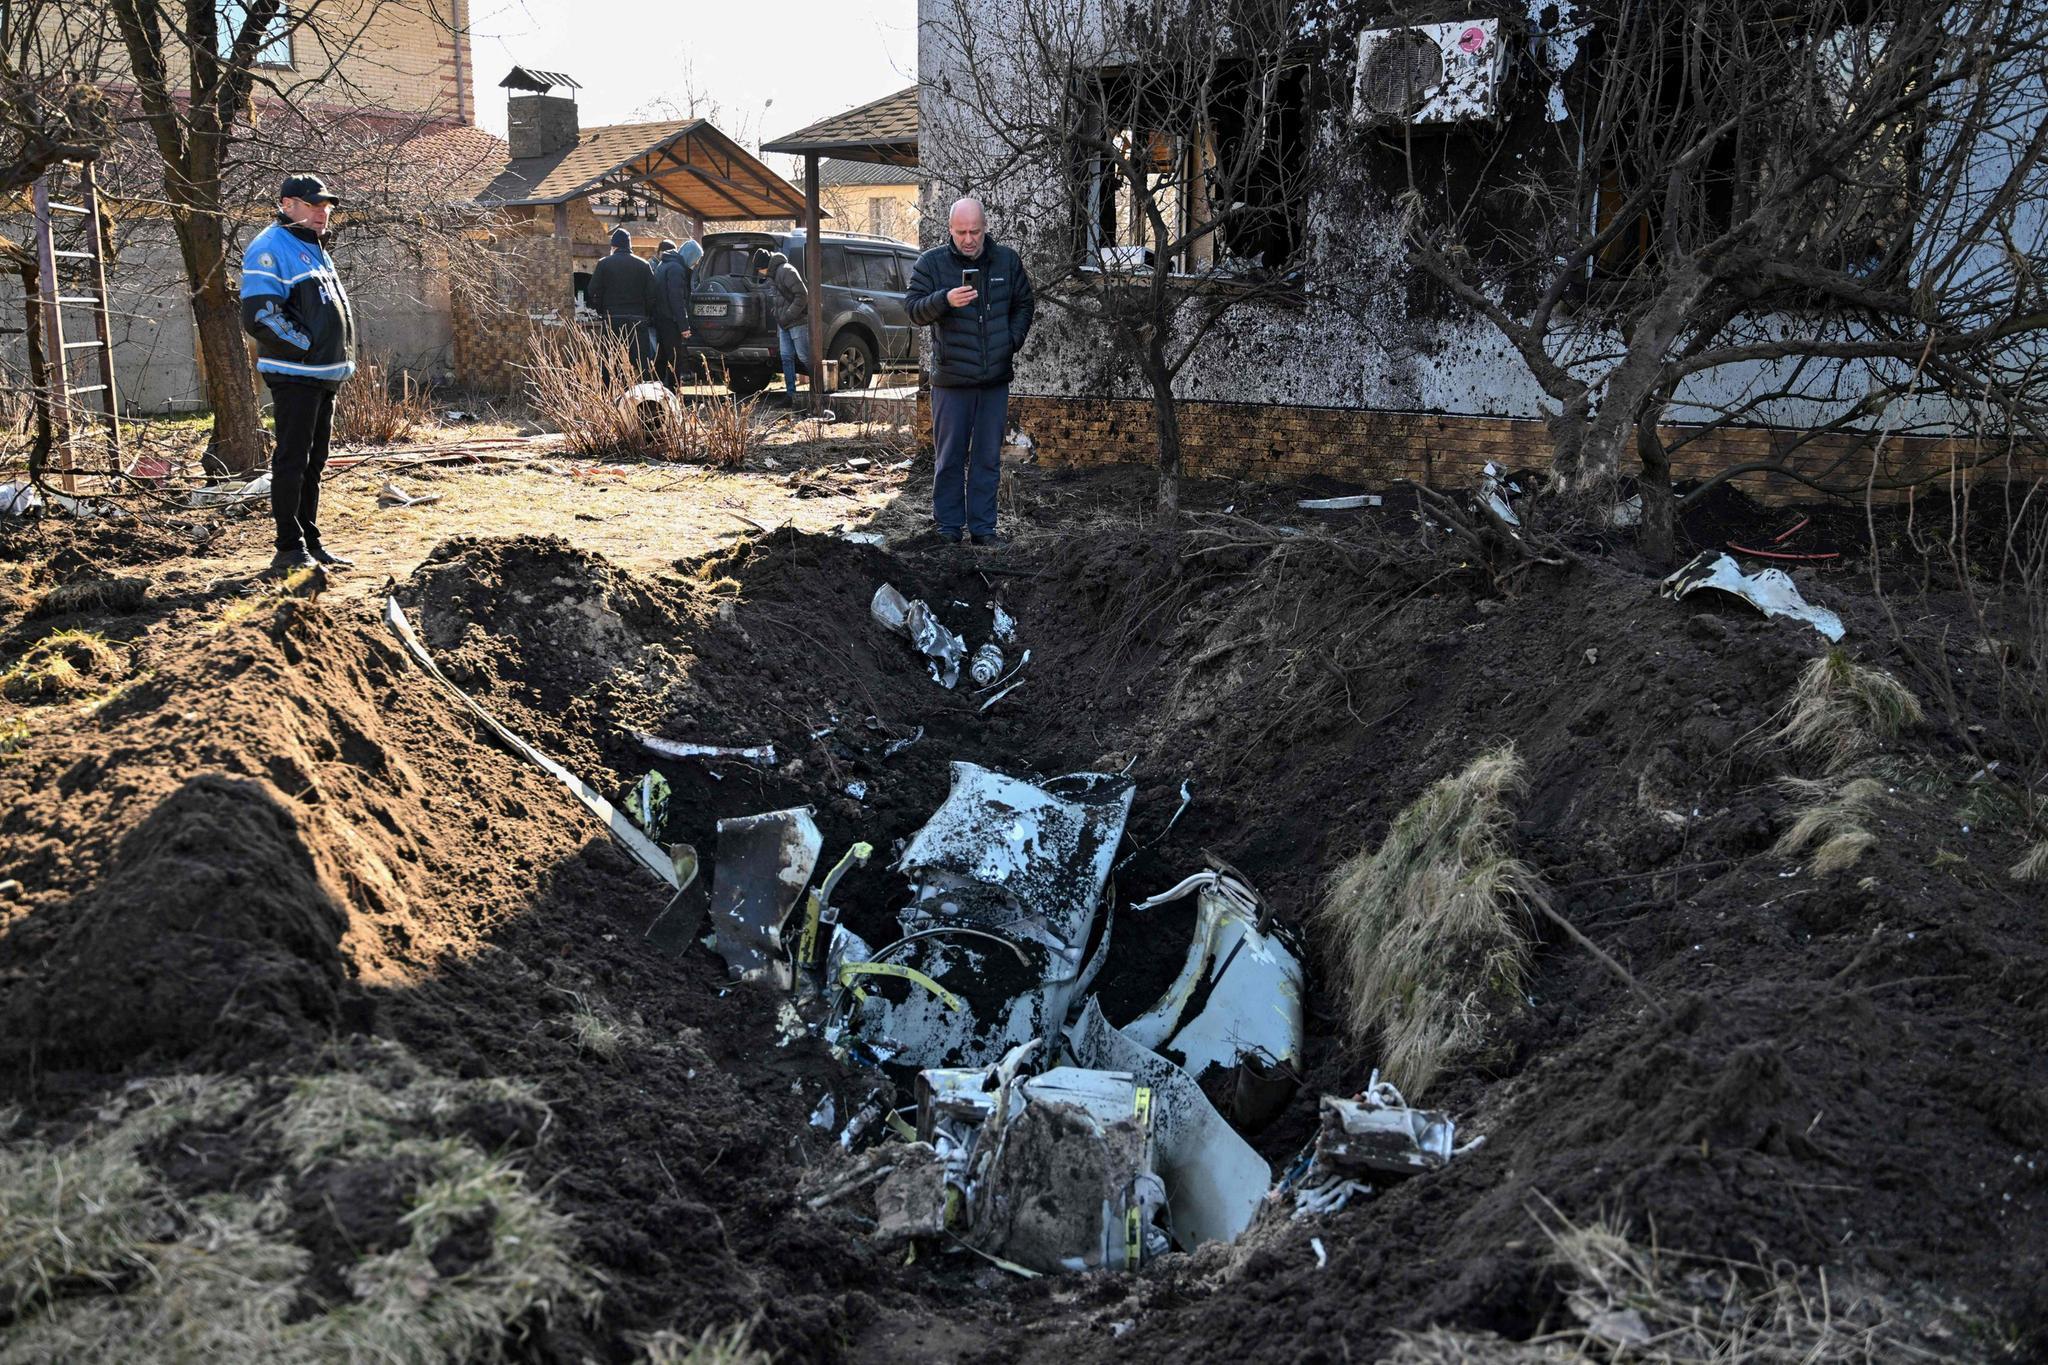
[469,0,918,165]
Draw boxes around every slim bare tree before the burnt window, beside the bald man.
[920,0,1313,510]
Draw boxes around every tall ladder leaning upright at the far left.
[35,162,121,493]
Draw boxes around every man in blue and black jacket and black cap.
[242,176,356,577]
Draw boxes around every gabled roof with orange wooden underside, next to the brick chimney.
[477,119,803,221]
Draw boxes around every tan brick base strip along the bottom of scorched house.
[937,395,2048,501]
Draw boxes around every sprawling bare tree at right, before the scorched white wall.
[1392,0,2048,557]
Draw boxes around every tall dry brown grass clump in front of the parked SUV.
[526,327,754,469]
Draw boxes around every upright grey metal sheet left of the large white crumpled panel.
[711,806,825,990]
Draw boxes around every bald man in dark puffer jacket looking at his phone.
[905,199,1034,544]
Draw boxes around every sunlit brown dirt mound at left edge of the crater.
[0,602,630,1070]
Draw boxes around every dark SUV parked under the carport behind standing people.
[688,231,918,393]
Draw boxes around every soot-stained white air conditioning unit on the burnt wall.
[1352,18,1503,123]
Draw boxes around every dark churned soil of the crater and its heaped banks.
[0,464,2048,1361]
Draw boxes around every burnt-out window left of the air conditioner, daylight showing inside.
[1073,61,1309,274]
